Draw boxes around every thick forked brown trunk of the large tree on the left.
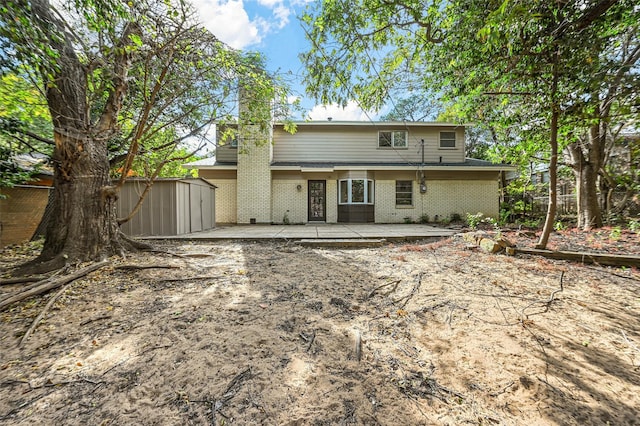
[20,0,139,273]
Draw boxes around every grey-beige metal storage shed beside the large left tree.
[117,178,216,236]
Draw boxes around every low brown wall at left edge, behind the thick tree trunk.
[0,187,50,247]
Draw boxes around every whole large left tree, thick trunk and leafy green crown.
[0,0,292,269]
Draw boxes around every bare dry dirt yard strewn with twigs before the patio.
[0,238,640,425]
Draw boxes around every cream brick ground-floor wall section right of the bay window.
[375,180,499,223]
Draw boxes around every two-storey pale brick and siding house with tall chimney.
[184,121,515,224]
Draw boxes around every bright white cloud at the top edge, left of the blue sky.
[193,0,264,49]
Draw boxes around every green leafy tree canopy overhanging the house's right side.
[302,0,640,245]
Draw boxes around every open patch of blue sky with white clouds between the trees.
[192,0,376,120]
